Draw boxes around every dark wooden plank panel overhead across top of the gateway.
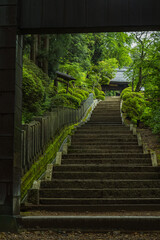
[19,0,160,33]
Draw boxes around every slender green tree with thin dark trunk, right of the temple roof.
[127,32,156,92]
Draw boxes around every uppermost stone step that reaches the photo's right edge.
[54,163,160,173]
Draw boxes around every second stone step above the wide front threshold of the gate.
[40,196,160,204]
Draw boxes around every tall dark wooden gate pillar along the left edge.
[0,0,22,231]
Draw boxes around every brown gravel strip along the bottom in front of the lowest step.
[0,231,160,240]
